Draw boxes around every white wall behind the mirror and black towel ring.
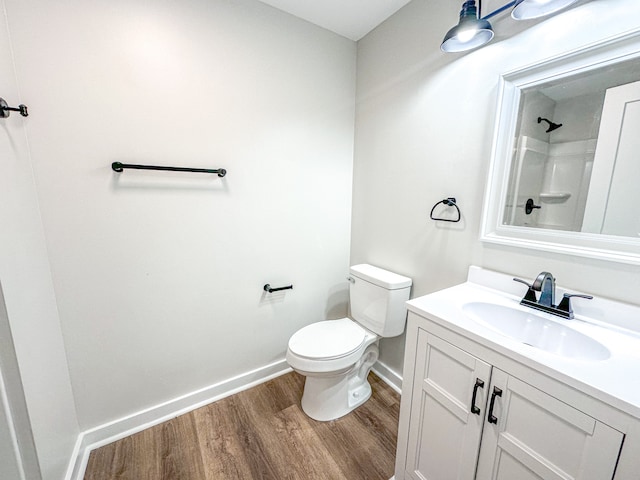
[351,0,640,371]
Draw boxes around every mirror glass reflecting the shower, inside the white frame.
[503,62,640,236]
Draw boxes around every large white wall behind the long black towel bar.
[7,0,356,430]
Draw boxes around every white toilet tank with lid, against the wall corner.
[349,264,411,337]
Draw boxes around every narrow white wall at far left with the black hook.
[0,1,79,480]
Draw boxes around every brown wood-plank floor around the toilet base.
[84,372,400,480]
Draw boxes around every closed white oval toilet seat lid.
[289,318,366,360]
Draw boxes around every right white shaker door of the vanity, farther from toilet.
[476,367,623,480]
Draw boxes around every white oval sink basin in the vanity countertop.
[462,302,611,360]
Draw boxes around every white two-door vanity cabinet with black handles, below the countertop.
[395,312,624,480]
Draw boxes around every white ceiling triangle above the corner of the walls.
[254,0,410,41]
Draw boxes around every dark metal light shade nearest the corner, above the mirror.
[440,0,493,52]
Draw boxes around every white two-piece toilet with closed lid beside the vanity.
[287,264,411,421]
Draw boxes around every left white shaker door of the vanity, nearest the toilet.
[405,329,491,480]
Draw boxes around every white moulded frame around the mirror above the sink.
[480,29,640,265]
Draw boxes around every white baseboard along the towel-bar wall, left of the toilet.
[65,359,291,480]
